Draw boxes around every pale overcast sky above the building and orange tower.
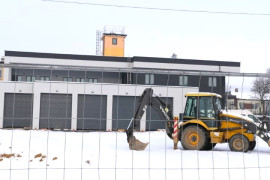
[0,0,270,97]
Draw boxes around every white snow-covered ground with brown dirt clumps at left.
[0,130,270,180]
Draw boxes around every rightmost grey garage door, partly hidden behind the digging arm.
[146,97,173,131]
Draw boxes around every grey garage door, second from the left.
[39,94,72,129]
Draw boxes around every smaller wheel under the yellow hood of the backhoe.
[229,134,250,152]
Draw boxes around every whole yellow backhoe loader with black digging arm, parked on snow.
[126,88,270,152]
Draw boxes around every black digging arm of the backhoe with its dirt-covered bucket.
[126,88,173,150]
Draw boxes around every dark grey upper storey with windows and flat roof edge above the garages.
[3,51,240,95]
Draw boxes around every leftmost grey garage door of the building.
[3,93,33,128]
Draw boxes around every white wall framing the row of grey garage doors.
[0,81,198,131]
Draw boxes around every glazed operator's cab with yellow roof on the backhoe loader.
[183,93,221,128]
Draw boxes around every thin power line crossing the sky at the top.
[42,0,270,16]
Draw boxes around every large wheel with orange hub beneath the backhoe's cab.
[181,125,210,150]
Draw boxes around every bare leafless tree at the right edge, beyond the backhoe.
[251,68,270,114]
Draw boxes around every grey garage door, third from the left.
[77,95,107,130]
